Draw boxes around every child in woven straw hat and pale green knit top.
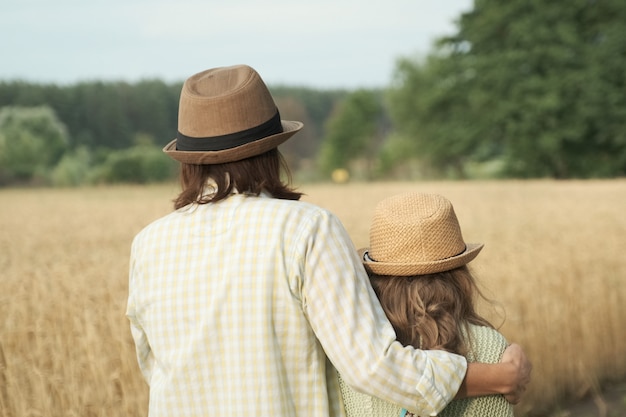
[340,192,513,417]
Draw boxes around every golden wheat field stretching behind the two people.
[0,180,626,417]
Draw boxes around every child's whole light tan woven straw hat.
[359,192,483,276]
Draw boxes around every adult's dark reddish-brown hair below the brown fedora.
[174,148,302,209]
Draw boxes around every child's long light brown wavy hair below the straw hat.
[370,265,493,355]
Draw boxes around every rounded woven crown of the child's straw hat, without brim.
[369,193,466,264]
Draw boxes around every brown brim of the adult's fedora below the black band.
[163,120,303,165]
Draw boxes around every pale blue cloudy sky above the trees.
[0,0,473,88]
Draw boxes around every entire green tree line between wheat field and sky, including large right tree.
[0,0,626,185]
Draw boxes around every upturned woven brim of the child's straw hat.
[359,243,484,277]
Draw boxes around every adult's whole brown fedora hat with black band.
[163,65,303,165]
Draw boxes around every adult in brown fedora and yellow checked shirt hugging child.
[127,65,530,417]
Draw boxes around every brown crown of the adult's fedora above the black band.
[178,65,277,138]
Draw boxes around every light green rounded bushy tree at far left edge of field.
[0,106,68,184]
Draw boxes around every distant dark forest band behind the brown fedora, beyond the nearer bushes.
[0,80,347,157]
